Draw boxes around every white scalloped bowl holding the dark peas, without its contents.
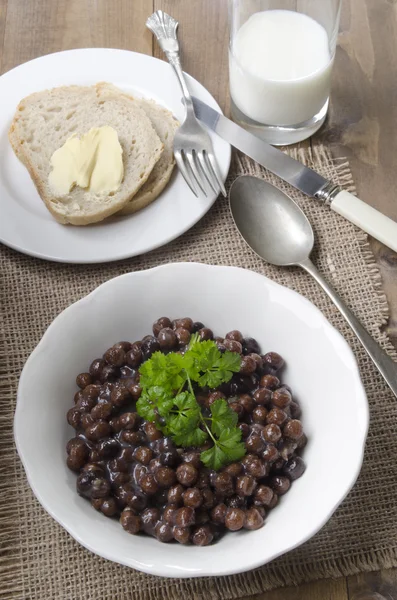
[15,263,369,577]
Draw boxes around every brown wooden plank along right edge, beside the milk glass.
[314,0,397,342]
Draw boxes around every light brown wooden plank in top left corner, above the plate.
[0,0,153,71]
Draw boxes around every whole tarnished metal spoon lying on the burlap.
[229,175,397,397]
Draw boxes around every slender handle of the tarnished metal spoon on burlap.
[299,259,397,397]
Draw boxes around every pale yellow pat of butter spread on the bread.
[48,125,124,196]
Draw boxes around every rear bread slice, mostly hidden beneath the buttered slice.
[96,82,179,215]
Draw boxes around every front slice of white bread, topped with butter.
[9,86,164,225]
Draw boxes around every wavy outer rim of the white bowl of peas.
[13,262,369,578]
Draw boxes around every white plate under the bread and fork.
[0,48,231,263]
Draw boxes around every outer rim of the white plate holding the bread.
[0,47,232,265]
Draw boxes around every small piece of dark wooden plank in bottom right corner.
[347,569,397,600]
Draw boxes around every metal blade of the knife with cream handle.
[193,97,329,197]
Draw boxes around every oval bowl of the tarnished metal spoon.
[229,175,314,267]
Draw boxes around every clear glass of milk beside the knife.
[229,0,342,146]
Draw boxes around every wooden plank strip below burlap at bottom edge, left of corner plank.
[240,578,344,600]
